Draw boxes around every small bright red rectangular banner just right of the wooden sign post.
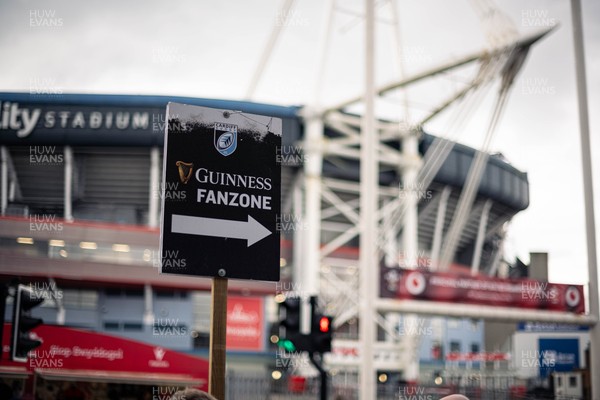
[227,296,265,351]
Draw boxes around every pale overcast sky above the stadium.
[0,0,600,283]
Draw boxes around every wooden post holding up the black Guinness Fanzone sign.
[208,277,227,400]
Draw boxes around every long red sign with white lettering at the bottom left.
[0,324,208,389]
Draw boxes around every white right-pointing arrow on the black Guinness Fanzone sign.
[171,214,272,247]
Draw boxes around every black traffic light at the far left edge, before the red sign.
[10,285,44,362]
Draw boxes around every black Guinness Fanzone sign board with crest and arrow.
[160,103,282,281]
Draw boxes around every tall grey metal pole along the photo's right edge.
[571,0,600,400]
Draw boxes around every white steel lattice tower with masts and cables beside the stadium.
[248,0,597,399]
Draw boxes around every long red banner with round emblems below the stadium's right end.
[380,266,585,314]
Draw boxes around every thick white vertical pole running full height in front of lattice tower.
[359,0,379,400]
